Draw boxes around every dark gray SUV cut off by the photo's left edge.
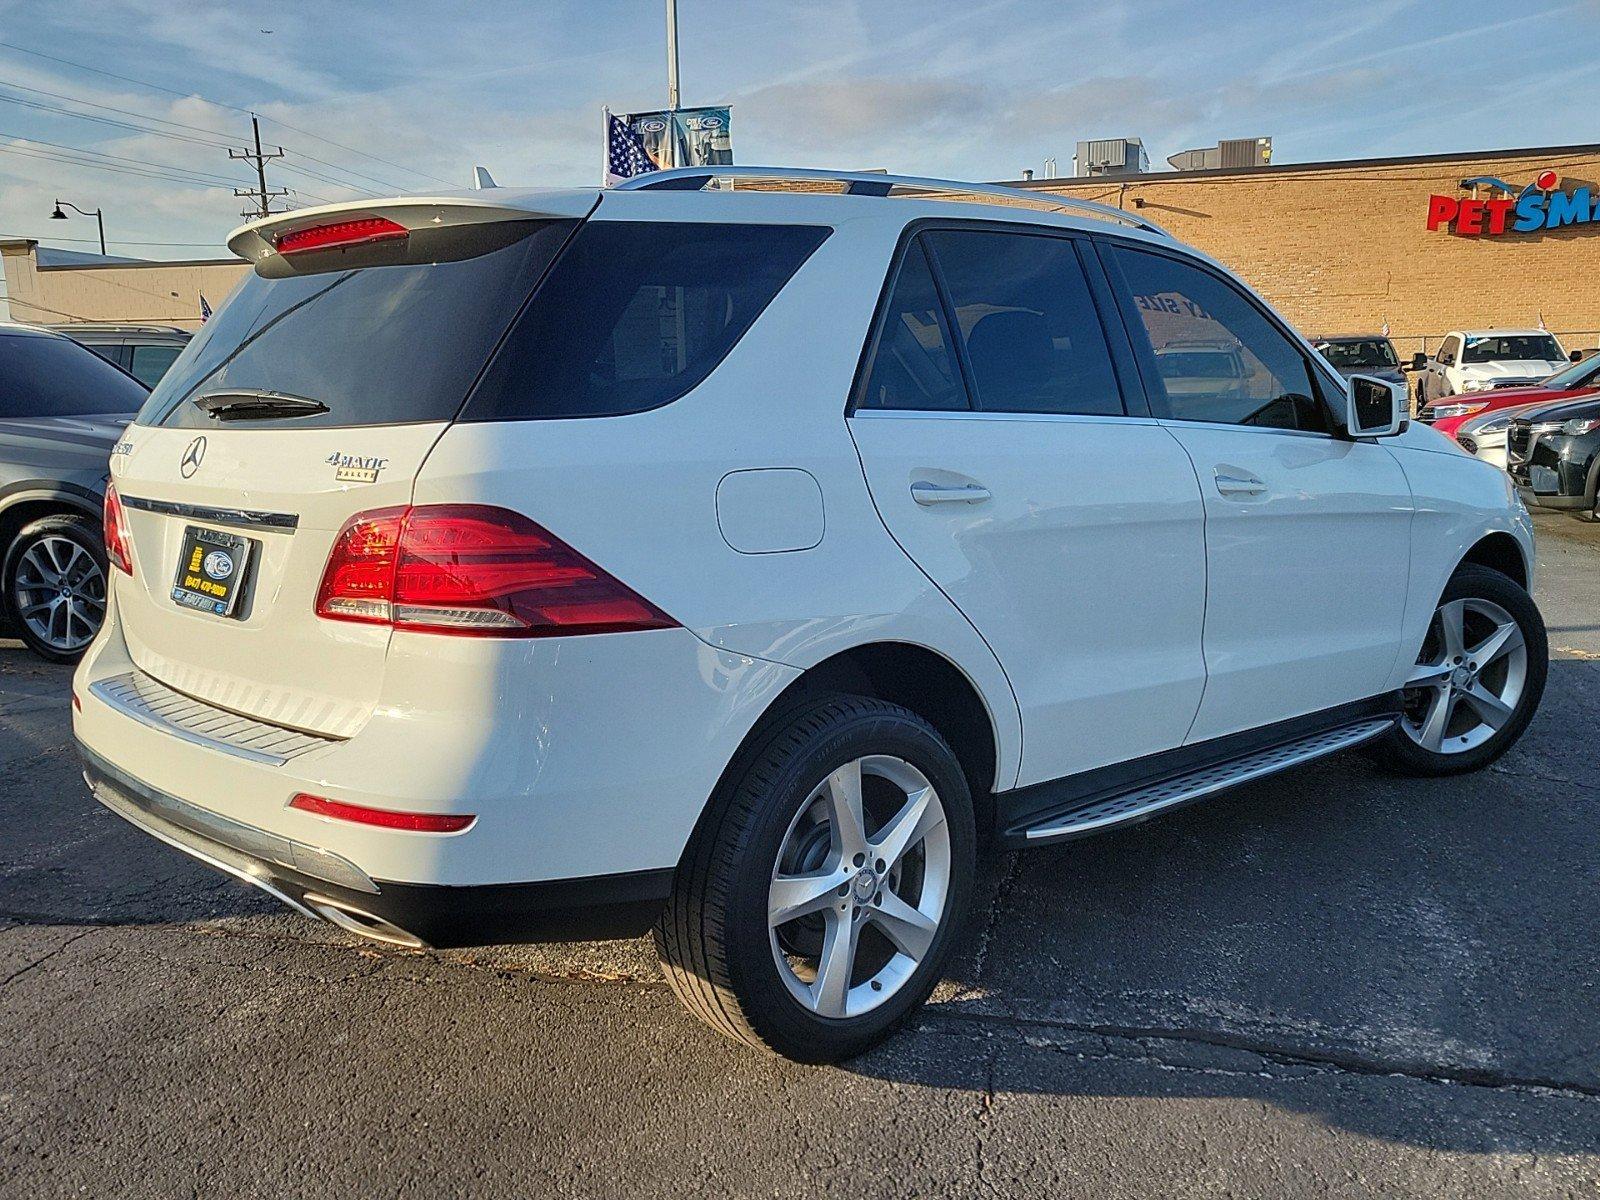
[0,323,149,662]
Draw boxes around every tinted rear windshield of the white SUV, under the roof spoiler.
[139,221,576,429]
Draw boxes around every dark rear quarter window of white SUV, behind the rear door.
[462,221,829,421]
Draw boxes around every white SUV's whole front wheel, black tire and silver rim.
[1373,563,1549,776]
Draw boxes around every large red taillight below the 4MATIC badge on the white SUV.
[317,504,677,637]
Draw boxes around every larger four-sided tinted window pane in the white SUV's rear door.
[926,230,1123,416]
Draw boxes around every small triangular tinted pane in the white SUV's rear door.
[856,240,968,410]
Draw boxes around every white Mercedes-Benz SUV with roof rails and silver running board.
[74,166,1546,1061]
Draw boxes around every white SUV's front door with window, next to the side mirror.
[1104,240,1413,741]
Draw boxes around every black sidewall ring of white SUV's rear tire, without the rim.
[726,706,976,1062]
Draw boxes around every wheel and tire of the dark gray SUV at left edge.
[0,514,110,662]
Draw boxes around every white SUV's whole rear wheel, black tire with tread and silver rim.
[656,696,976,1062]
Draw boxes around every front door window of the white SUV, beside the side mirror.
[1110,246,1328,432]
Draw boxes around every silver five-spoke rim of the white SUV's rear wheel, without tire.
[766,755,950,1018]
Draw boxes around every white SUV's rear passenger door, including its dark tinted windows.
[850,226,1205,786]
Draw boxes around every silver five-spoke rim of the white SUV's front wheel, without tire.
[1402,598,1528,754]
